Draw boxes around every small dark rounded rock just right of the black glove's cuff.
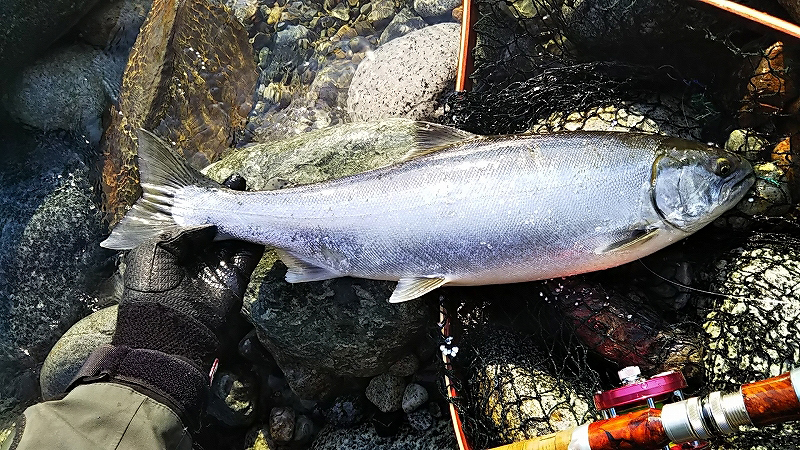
[206,370,258,427]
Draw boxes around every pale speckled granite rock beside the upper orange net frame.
[347,23,460,121]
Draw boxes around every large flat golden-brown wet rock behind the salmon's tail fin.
[103,0,257,220]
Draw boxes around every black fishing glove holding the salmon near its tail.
[73,175,264,429]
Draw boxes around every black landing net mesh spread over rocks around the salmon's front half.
[434,0,800,449]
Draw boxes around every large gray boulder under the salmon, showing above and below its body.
[207,119,435,399]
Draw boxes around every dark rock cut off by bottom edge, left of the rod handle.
[311,418,458,450]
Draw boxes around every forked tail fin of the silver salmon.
[100,129,220,250]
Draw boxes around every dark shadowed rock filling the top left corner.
[0,0,97,80]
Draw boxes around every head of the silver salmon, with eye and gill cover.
[650,138,755,233]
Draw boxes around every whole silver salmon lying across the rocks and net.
[102,123,754,302]
